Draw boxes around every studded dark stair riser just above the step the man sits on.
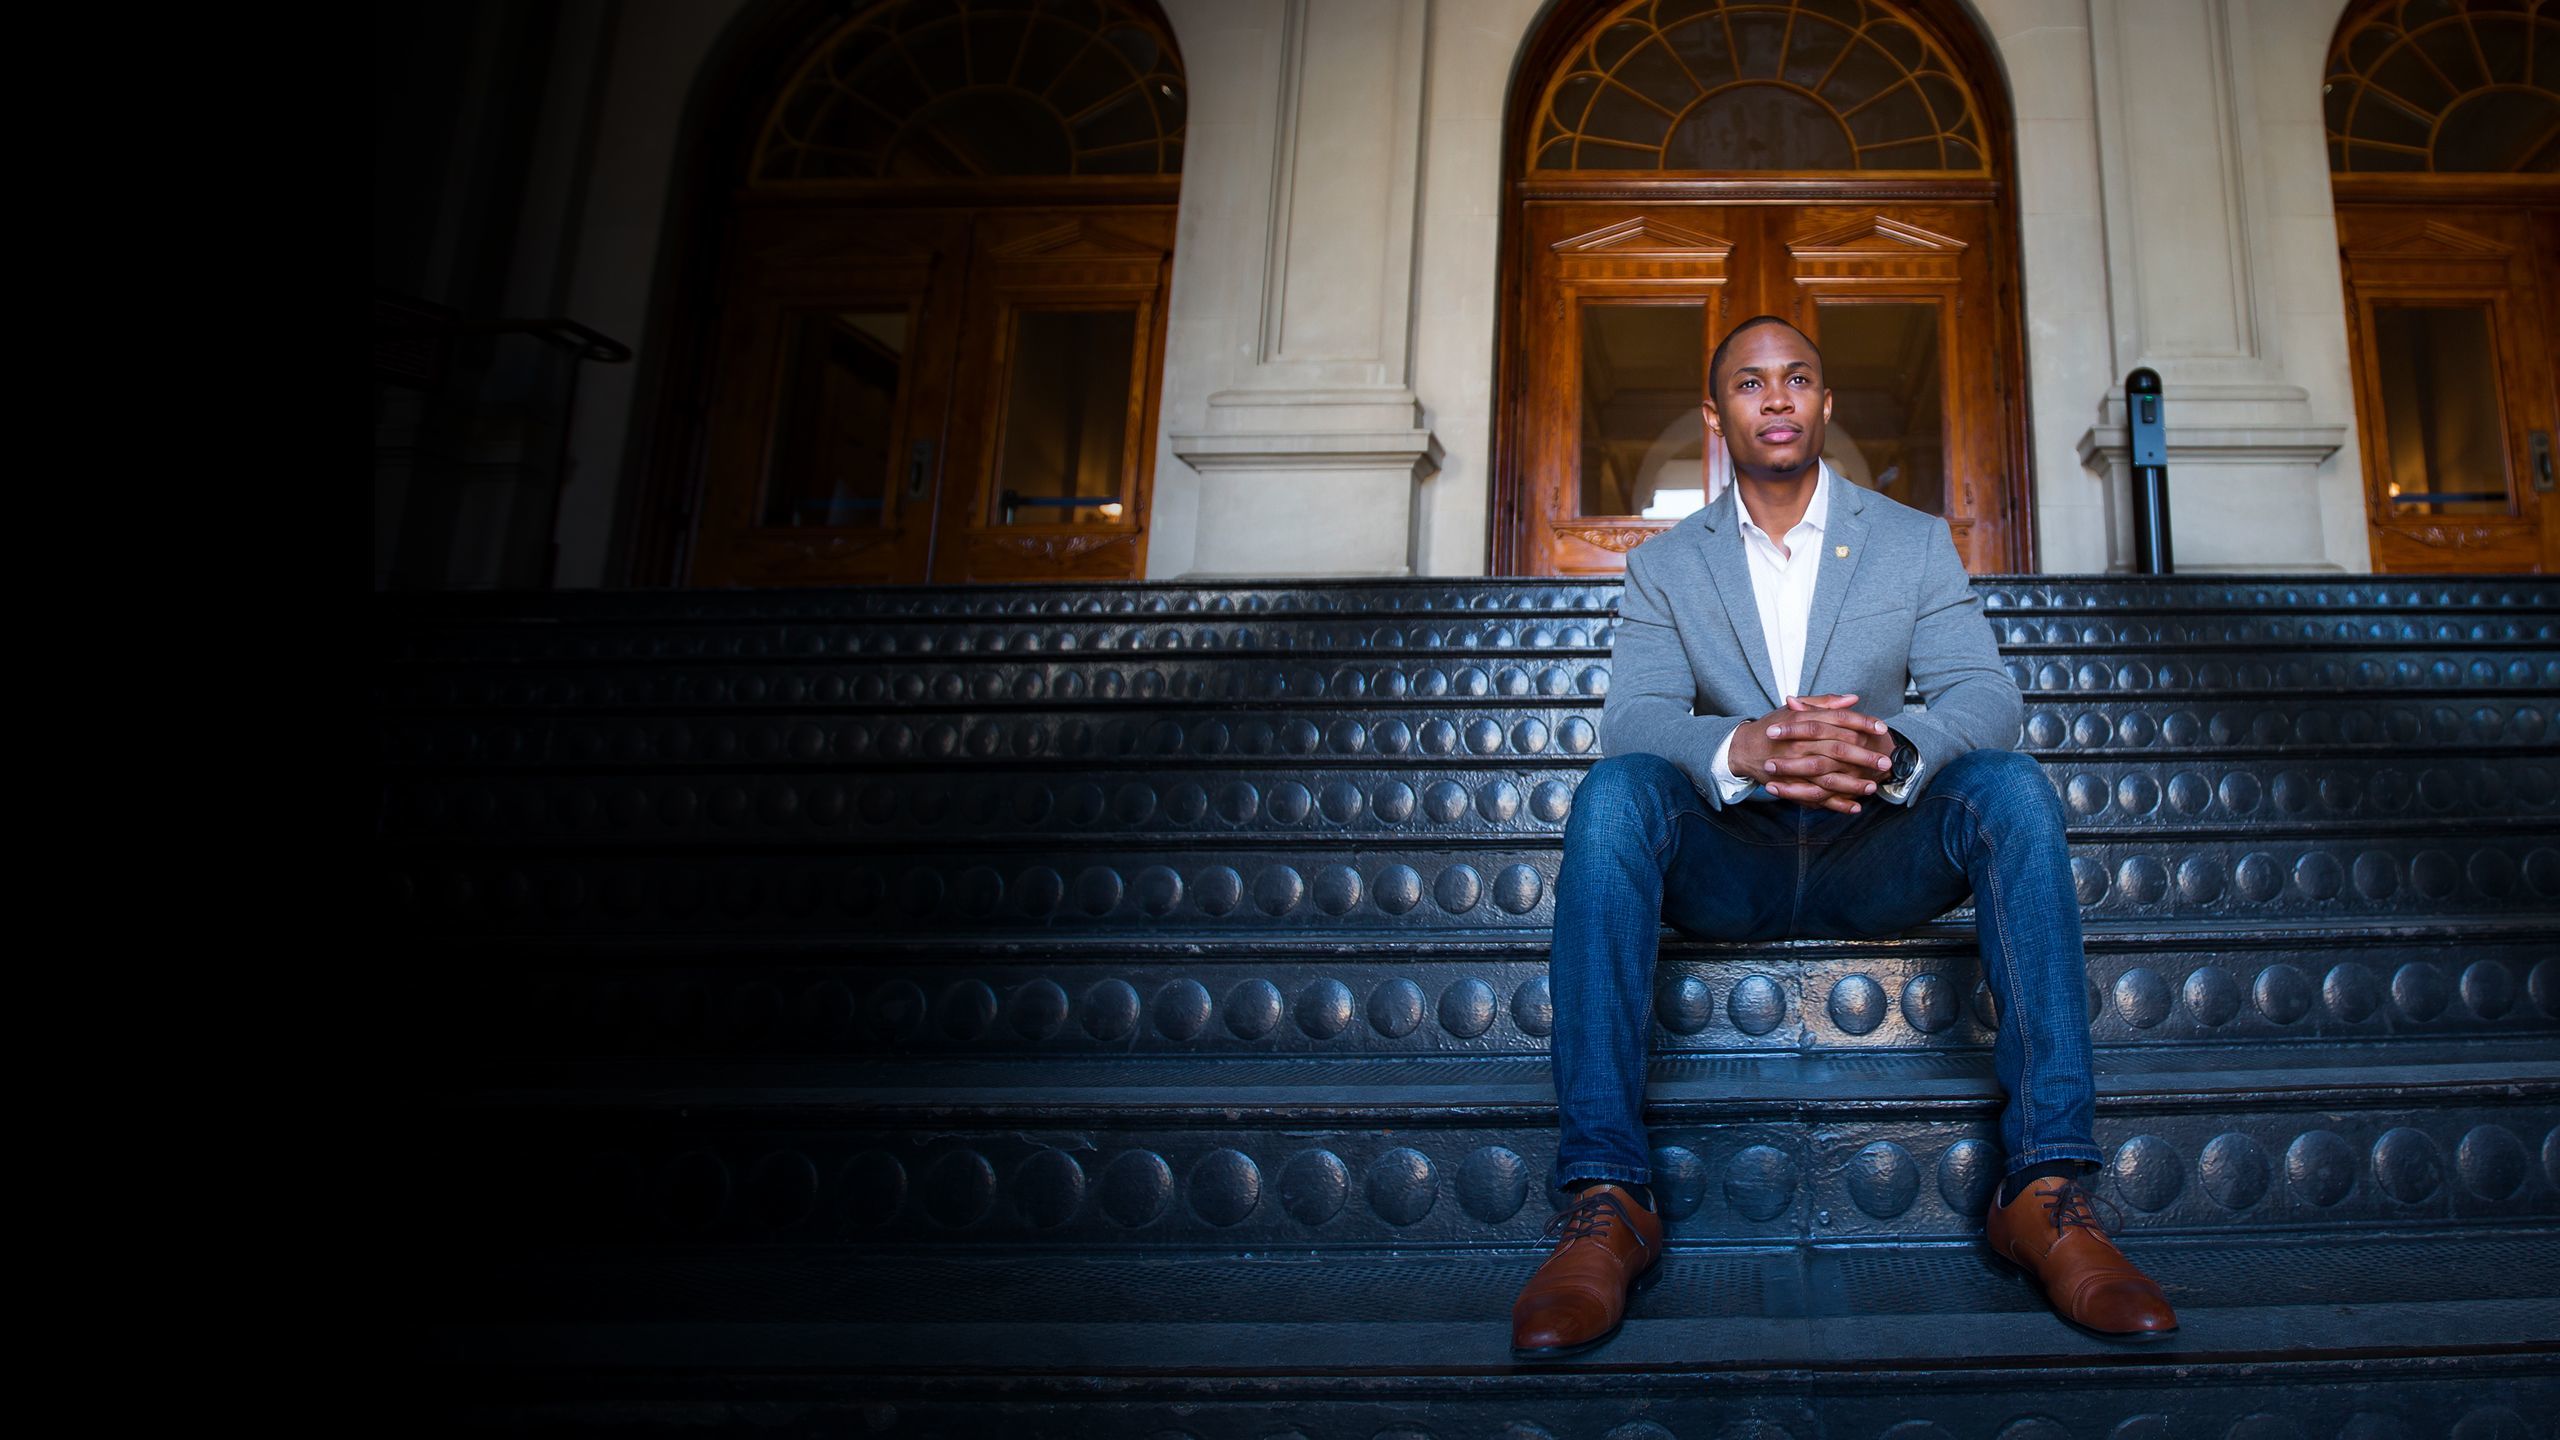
[376,817,2560,938]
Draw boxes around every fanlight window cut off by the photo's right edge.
[2319,0,2560,174]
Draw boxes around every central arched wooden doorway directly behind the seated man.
[1492,0,2033,574]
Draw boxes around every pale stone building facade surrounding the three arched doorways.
[371,0,2560,587]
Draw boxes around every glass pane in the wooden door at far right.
[2373,305,2509,515]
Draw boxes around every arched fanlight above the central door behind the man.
[1528,0,1989,174]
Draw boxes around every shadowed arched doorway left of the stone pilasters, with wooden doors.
[660,0,1188,584]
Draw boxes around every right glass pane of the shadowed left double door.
[996,310,1137,525]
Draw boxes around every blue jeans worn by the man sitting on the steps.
[1546,751,2104,1186]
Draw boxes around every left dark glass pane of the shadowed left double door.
[763,310,906,525]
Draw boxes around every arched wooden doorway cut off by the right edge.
[2322,0,2560,571]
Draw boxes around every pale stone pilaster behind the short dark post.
[2078,0,2368,571]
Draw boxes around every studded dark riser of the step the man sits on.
[445,917,2560,1058]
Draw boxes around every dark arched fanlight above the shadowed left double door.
[753,0,1188,184]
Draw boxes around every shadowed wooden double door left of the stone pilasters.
[689,205,1172,584]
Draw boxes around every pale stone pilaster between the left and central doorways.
[1149,0,1441,577]
